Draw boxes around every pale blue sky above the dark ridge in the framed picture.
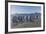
[10,5,41,14]
